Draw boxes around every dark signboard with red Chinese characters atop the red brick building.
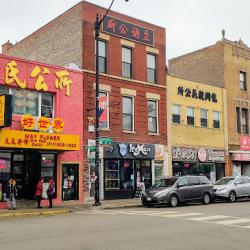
[102,16,154,46]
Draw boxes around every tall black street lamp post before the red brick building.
[94,0,129,206]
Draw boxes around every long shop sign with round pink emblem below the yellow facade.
[172,147,226,163]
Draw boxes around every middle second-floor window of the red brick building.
[122,96,134,131]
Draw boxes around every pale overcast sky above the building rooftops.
[0,0,250,59]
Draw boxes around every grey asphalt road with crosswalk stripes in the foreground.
[0,201,250,250]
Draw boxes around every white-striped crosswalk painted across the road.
[93,209,250,229]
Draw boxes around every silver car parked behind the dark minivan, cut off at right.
[214,176,250,202]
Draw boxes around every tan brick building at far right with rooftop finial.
[169,37,250,178]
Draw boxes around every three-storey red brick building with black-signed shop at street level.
[3,1,167,199]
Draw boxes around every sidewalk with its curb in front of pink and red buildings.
[0,199,141,220]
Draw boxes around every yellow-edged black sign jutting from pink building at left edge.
[0,95,12,128]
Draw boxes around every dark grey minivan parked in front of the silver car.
[142,176,214,207]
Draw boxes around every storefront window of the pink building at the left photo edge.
[0,152,11,201]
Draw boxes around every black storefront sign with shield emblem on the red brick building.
[104,142,155,159]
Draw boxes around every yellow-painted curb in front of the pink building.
[0,209,71,219]
